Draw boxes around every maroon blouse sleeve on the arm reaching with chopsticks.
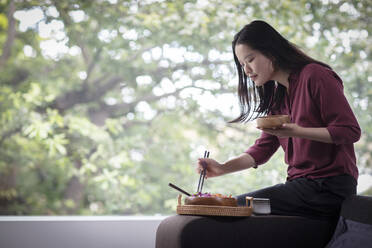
[245,132,280,168]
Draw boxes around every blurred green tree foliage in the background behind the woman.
[0,0,372,215]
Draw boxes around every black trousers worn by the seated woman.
[237,174,357,219]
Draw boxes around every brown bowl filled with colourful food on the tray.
[185,192,238,207]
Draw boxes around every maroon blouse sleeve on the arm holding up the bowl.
[309,65,361,145]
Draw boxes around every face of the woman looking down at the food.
[235,44,275,86]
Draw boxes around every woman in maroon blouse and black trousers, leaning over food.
[197,21,361,218]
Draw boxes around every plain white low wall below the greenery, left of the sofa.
[0,216,166,248]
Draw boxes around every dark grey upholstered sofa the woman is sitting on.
[156,196,372,248]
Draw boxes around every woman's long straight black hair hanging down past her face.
[230,20,331,123]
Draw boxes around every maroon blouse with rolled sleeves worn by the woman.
[246,63,361,180]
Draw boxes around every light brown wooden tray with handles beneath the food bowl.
[177,195,253,217]
